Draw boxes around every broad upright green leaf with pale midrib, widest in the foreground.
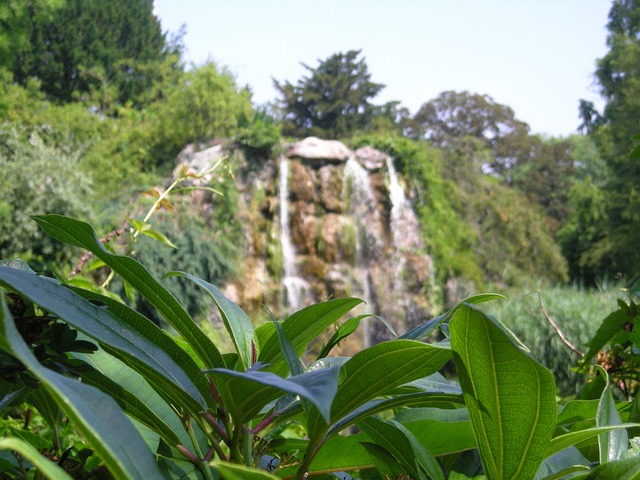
[450,305,556,479]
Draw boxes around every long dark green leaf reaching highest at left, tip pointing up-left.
[33,215,224,368]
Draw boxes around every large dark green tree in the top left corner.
[12,0,175,110]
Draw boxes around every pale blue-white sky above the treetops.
[156,0,612,136]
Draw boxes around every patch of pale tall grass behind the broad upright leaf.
[484,283,624,397]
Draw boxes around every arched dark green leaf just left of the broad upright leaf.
[308,340,451,440]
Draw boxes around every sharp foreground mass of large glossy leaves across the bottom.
[0,215,640,479]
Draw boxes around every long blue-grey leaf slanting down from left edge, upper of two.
[0,267,206,412]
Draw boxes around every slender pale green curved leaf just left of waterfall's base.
[165,272,257,368]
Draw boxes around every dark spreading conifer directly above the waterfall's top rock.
[274,50,384,138]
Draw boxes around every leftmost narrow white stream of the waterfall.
[278,155,309,313]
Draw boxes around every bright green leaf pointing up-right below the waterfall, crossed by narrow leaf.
[258,298,362,373]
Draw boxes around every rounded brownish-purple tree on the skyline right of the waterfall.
[410,91,574,233]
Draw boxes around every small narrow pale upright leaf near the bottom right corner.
[596,366,629,463]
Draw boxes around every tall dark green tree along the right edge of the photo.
[580,0,640,278]
